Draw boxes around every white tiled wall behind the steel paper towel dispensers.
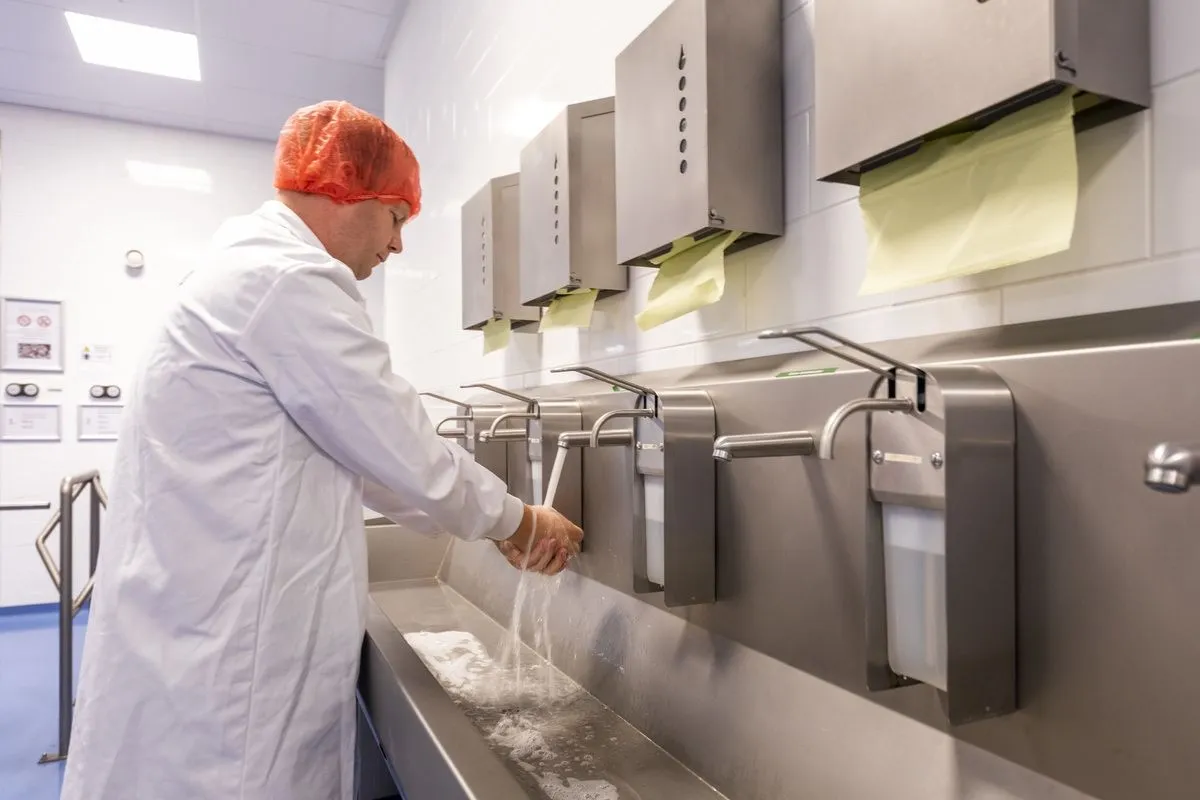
[385,0,1200,400]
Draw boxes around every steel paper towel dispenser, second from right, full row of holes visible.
[616,0,784,266]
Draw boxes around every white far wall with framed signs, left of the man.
[0,104,272,606]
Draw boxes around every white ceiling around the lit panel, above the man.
[0,0,408,140]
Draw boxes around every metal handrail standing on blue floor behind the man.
[35,470,108,764]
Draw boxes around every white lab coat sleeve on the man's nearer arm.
[239,268,524,541]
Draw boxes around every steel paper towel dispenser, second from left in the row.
[520,97,629,306]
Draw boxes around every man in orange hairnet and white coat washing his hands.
[62,103,582,800]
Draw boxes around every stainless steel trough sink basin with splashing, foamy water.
[360,577,724,800]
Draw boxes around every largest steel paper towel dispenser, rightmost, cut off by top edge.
[814,0,1151,184]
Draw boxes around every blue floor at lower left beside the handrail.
[0,607,88,800]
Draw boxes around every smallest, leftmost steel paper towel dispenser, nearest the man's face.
[462,173,541,330]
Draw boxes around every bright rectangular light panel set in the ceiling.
[64,11,200,80]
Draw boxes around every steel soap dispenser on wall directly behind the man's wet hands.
[463,384,583,525]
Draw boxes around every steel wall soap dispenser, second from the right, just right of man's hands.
[551,367,716,607]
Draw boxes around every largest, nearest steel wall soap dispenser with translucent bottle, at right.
[762,327,1016,724]
